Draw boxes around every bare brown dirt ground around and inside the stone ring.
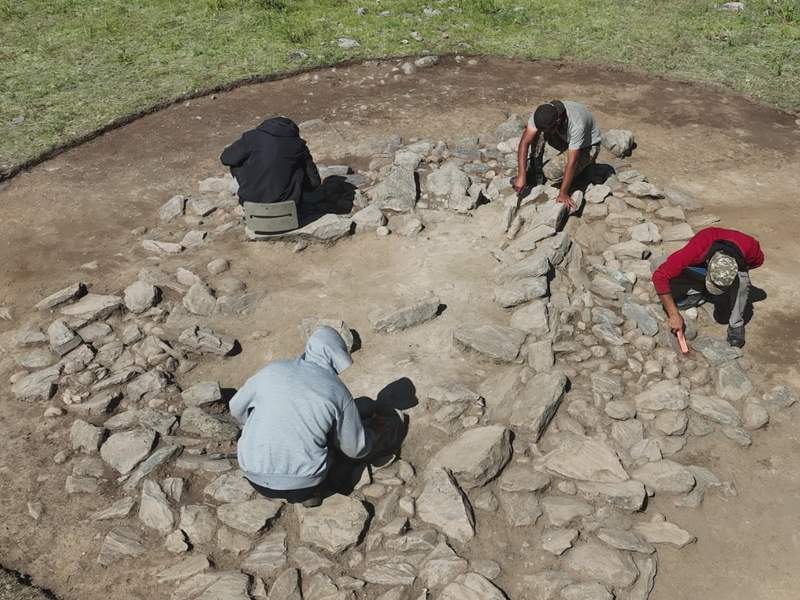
[0,58,800,600]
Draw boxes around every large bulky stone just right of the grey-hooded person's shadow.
[428,425,511,489]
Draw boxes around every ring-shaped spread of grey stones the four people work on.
[3,116,797,600]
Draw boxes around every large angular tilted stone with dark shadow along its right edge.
[492,371,567,441]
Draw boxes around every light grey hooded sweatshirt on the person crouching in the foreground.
[230,327,371,490]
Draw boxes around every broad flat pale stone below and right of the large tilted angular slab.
[544,438,628,483]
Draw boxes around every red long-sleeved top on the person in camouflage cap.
[653,227,764,294]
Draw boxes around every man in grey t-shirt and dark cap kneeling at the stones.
[514,100,601,210]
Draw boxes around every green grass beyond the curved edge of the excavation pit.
[0,0,800,170]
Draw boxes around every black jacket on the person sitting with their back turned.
[220,117,320,204]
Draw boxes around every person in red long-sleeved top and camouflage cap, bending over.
[653,227,764,348]
